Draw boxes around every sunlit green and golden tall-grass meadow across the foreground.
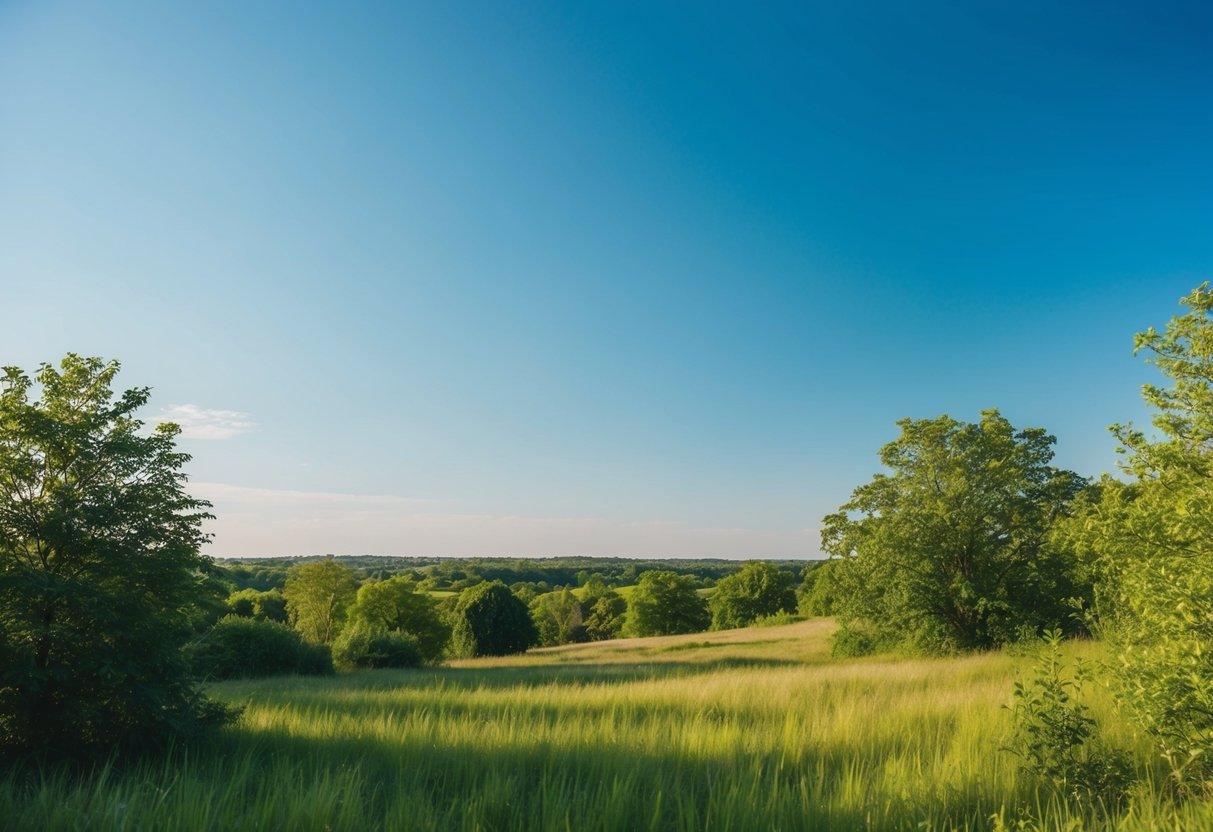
[0,620,1213,831]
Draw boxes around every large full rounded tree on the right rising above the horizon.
[821,410,1089,650]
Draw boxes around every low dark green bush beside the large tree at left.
[186,615,332,679]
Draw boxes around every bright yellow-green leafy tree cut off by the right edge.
[1063,283,1213,792]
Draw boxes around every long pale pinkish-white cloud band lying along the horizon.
[189,483,818,558]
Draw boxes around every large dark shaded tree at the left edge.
[0,354,220,756]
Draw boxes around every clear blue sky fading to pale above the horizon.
[0,0,1213,557]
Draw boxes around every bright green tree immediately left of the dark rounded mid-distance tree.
[349,576,451,667]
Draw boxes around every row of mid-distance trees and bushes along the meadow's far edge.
[196,557,813,678]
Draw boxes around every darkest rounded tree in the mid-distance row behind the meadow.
[451,581,539,656]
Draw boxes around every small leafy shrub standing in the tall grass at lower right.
[1008,629,1132,804]
